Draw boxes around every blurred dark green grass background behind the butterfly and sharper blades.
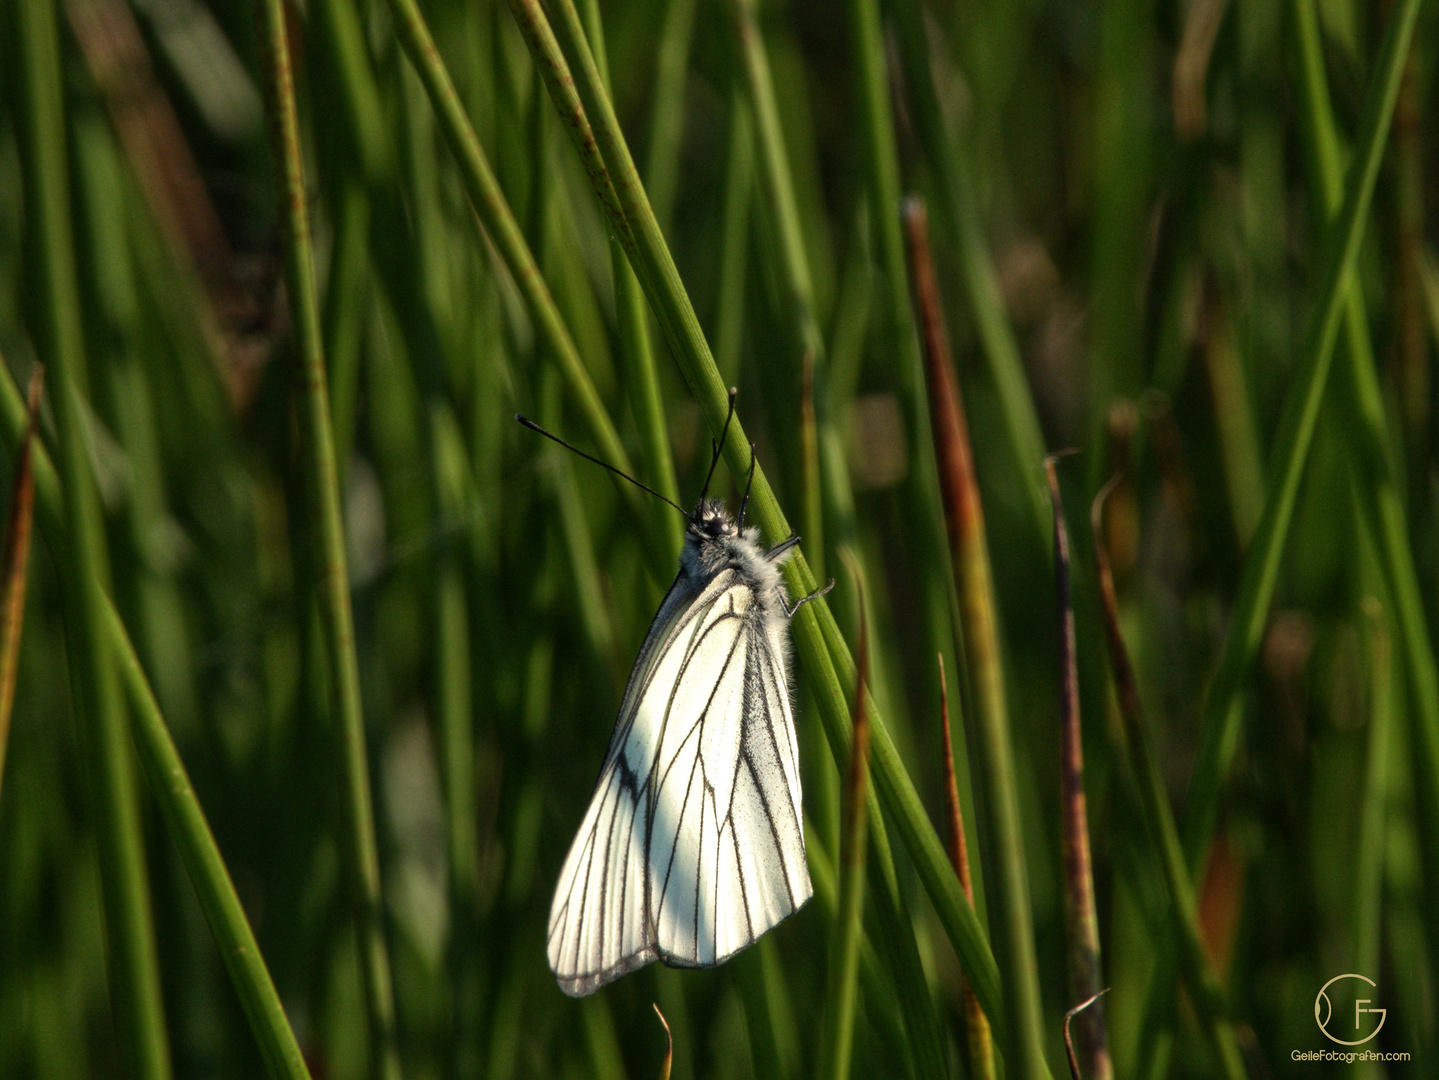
[0,0,1439,1080]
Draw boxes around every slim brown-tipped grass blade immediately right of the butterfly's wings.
[819,549,869,1080]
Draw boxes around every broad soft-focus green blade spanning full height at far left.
[16,0,170,1080]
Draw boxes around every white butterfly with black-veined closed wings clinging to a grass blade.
[526,400,833,997]
